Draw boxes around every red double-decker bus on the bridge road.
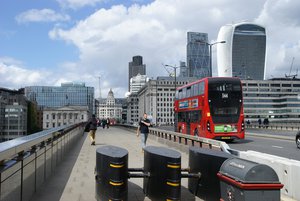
[174,77,245,141]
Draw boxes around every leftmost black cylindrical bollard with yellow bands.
[96,146,128,201]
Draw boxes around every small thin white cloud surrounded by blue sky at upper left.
[16,9,70,23]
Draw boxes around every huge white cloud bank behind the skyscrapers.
[1,0,300,97]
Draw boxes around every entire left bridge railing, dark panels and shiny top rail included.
[0,123,85,201]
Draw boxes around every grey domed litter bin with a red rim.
[218,158,283,201]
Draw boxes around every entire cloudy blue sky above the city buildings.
[0,0,300,98]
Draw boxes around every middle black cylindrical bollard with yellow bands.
[143,146,181,201]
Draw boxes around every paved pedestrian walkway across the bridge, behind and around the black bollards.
[32,127,201,201]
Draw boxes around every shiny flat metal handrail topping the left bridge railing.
[0,123,83,163]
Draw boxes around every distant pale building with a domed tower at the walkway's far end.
[99,89,122,120]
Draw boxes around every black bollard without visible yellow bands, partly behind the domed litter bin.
[188,147,234,201]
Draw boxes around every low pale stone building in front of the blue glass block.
[43,106,89,130]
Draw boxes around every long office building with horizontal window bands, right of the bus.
[242,78,300,123]
